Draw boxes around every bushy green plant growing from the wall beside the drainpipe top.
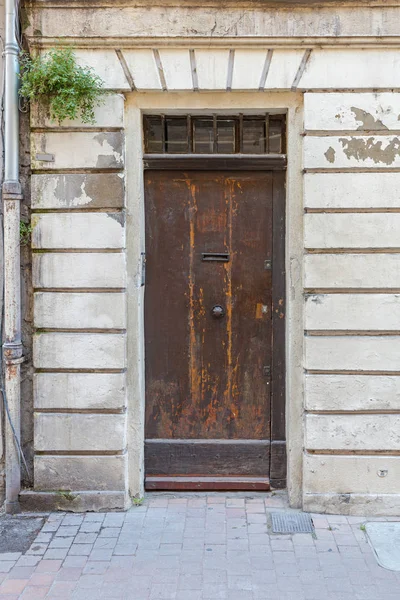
[19,47,107,124]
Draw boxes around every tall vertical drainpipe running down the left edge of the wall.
[2,0,23,513]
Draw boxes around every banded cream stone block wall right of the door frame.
[303,91,400,514]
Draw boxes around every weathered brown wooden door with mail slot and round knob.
[145,170,285,489]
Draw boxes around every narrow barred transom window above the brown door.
[143,114,286,154]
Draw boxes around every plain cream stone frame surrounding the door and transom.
[125,92,303,507]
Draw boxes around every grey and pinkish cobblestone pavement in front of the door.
[0,494,400,600]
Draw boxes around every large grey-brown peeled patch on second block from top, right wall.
[340,137,400,165]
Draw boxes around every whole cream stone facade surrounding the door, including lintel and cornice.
[27,3,400,514]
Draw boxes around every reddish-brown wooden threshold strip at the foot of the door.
[145,476,271,492]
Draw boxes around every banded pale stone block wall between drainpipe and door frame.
[28,95,127,510]
